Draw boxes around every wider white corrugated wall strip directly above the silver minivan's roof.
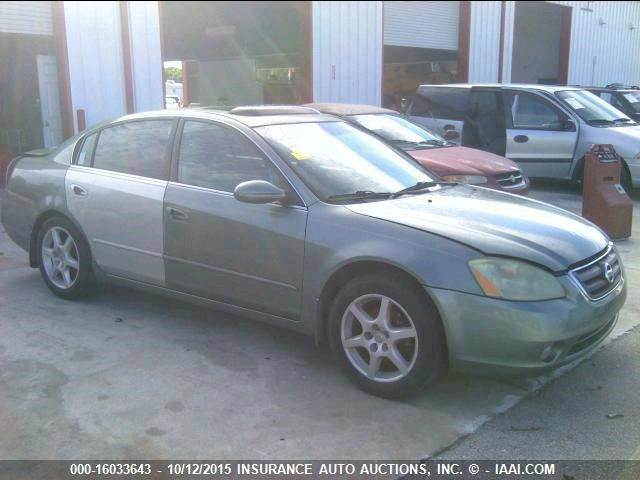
[469,2,501,82]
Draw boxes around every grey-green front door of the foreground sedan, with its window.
[164,120,307,320]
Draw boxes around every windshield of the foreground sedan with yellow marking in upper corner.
[256,122,437,201]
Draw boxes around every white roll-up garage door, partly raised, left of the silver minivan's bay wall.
[384,1,460,50]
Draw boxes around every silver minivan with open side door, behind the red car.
[407,84,640,188]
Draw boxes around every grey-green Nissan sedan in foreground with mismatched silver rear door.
[1,107,626,397]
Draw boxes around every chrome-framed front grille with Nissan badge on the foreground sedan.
[571,246,622,300]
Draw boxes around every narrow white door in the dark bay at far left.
[37,55,62,148]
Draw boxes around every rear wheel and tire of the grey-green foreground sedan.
[37,217,94,300]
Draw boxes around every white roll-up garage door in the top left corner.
[0,2,53,35]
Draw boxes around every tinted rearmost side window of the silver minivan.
[411,87,470,120]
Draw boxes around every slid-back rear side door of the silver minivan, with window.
[408,87,470,145]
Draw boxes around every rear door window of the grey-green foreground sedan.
[93,120,174,180]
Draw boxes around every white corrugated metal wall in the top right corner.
[553,2,640,85]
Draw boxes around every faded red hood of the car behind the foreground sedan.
[407,147,519,176]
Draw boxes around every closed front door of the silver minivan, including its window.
[505,90,578,178]
